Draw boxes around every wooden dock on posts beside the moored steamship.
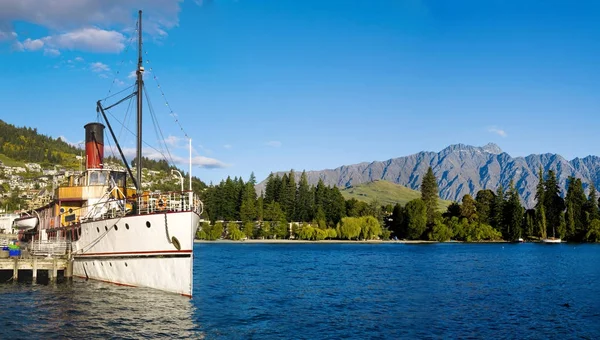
[0,257,73,282]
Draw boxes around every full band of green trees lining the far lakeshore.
[199,167,600,242]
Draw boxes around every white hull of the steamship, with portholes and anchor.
[73,211,199,297]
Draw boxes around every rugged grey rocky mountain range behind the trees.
[257,143,600,208]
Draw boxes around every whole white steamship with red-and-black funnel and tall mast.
[24,11,202,297]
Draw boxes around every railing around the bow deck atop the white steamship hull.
[137,191,201,214]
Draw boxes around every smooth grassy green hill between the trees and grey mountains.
[342,181,452,210]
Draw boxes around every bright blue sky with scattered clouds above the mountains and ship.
[0,0,600,182]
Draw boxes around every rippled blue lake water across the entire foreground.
[0,243,600,339]
